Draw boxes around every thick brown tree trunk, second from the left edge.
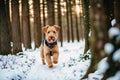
[11,0,22,54]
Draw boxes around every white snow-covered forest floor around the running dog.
[0,41,90,80]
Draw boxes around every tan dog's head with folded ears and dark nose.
[42,25,60,43]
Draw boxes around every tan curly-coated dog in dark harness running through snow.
[40,25,60,68]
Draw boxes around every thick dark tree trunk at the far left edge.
[0,0,11,55]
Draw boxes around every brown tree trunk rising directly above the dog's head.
[46,0,55,26]
